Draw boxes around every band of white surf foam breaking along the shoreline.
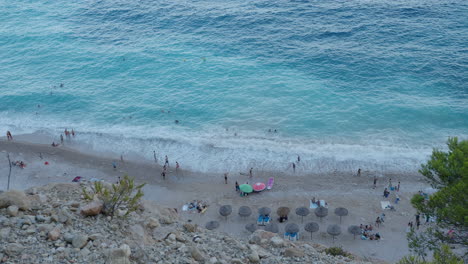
[0,112,438,174]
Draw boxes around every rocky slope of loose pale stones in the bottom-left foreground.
[0,183,372,264]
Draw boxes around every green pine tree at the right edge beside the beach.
[411,137,468,251]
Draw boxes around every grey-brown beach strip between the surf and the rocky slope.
[0,136,429,263]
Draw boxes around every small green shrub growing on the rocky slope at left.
[83,175,145,216]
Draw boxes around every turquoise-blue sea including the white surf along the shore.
[0,0,468,172]
